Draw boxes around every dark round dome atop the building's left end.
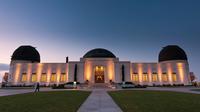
[11,46,40,63]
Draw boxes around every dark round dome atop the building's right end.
[159,45,188,62]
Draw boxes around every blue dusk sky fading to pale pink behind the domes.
[0,0,200,80]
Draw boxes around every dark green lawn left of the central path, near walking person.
[0,91,90,112]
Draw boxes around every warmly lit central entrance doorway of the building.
[94,66,104,83]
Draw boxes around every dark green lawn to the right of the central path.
[109,90,200,112]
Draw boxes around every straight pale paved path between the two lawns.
[78,89,122,112]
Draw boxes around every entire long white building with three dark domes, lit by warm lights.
[9,45,190,86]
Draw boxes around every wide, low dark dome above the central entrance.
[83,48,116,58]
